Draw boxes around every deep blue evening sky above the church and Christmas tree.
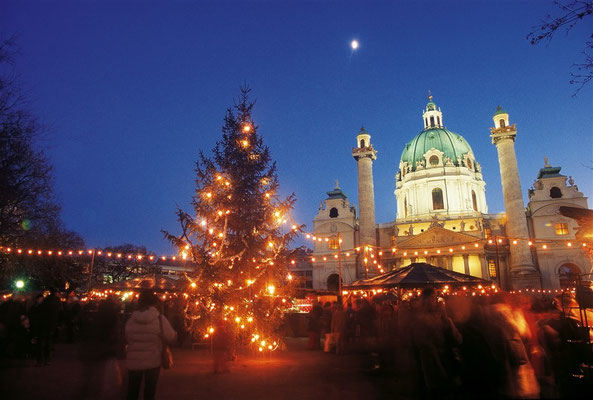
[0,0,593,254]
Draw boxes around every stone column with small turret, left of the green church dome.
[352,127,377,246]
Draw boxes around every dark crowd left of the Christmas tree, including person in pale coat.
[0,290,182,399]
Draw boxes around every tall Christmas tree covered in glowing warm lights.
[165,87,302,351]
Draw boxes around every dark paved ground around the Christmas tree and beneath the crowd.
[0,339,400,400]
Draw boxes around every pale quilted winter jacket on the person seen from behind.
[125,307,177,370]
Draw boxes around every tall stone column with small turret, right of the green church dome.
[490,106,541,289]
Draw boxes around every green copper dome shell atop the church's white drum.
[401,128,473,171]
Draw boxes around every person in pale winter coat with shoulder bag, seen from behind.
[125,291,177,400]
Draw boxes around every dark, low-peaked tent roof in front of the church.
[344,263,490,289]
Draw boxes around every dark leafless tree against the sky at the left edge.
[0,38,60,246]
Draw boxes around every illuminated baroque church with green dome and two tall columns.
[313,96,591,290]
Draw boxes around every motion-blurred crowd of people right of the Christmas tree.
[308,288,593,398]
